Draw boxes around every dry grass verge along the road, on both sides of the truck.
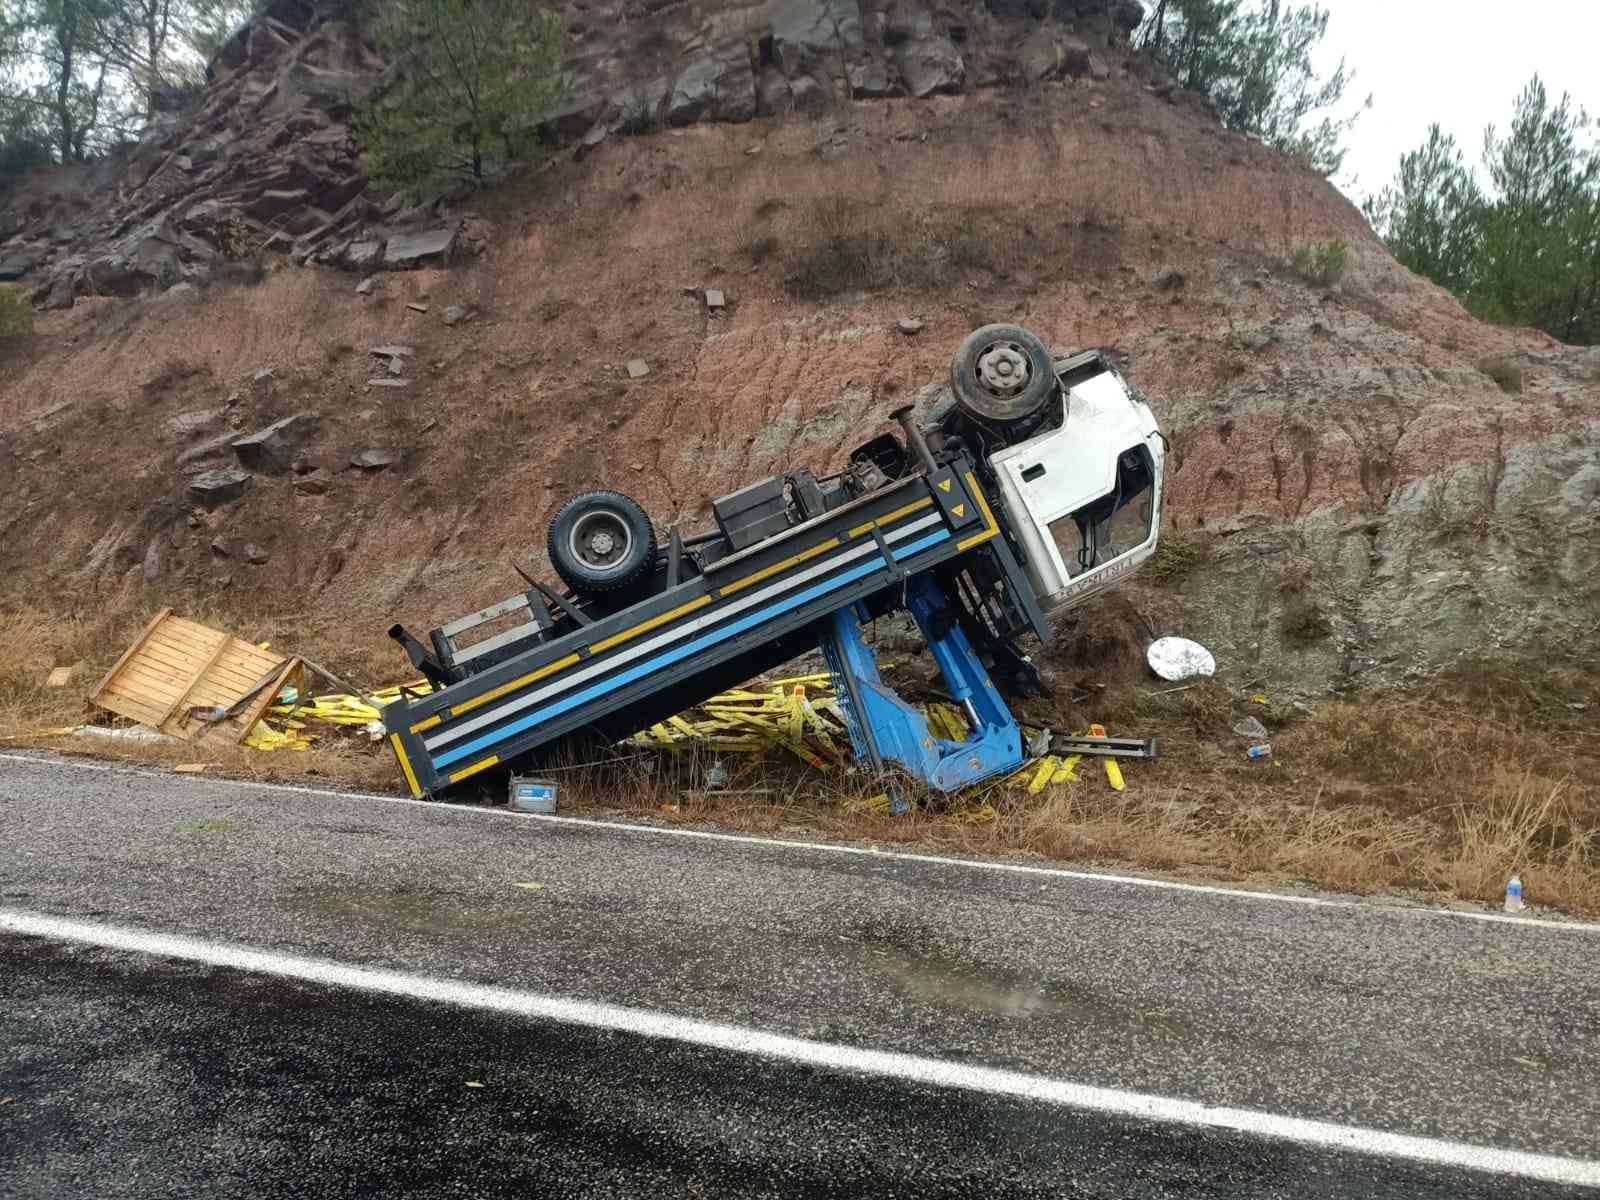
[0,610,1600,914]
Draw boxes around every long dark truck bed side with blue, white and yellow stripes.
[384,459,1024,797]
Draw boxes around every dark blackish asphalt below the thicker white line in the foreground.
[0,936,1592,1200]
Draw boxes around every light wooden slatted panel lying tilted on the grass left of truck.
[90,608,306,742]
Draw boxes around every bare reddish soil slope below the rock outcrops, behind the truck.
[0,82,1600,691]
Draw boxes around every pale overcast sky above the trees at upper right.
[1315,0,1600,203]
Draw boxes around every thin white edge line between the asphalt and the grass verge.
[9,754,1600,934]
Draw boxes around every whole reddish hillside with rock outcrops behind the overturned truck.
[0,0,1600,696]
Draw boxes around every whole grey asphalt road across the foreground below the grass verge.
[0,760,1600,1197]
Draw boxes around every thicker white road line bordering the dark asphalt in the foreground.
[0,909,1600,1187]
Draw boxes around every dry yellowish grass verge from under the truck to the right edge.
[540,680,1600,914]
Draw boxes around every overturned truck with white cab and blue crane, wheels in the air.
[384,325,1165,797]
